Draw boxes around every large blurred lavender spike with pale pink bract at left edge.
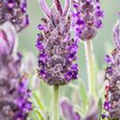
[0,22,32,120]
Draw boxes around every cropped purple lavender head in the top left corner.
[0,0,29,32]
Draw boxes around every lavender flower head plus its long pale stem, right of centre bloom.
[72,0,104,96]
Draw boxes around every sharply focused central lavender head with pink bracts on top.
[36,0,78,85]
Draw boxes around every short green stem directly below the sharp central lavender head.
[53,85,59,120]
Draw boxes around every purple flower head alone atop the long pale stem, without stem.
[72,0,104,40]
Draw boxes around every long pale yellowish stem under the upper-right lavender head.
[85,40,96,96]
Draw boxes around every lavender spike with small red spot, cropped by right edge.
[104,21,120,120]
